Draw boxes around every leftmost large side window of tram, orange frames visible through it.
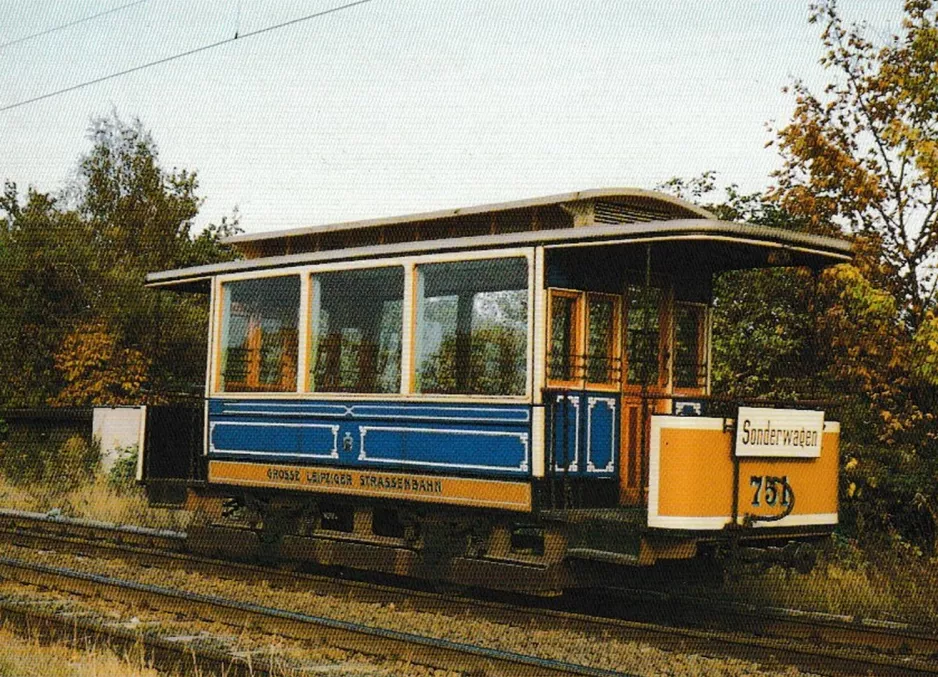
[219,275,300,392]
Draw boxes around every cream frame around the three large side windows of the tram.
[207,246,538,404]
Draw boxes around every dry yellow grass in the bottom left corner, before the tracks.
[0,628,159,677]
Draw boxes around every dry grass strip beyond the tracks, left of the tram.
[0,475,190,529]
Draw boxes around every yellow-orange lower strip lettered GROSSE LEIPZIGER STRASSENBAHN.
[208,461,531,512]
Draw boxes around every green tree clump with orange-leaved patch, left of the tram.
[0,113,238,406]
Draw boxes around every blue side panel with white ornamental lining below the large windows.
[209,399,531,476]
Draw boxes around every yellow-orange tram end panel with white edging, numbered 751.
[648,416,840,529]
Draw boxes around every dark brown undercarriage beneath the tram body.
[168,486,827,595]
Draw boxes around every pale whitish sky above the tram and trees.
[0,0,902,232]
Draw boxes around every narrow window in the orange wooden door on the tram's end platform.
[625,285,661,386]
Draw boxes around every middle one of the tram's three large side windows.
[309,267,404,393]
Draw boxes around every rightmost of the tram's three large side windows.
[415,258,528,395]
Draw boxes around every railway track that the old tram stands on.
[0,511,938,675]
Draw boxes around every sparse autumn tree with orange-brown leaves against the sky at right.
[771,0,938,331]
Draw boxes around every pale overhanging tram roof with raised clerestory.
[147,189,852,291]
